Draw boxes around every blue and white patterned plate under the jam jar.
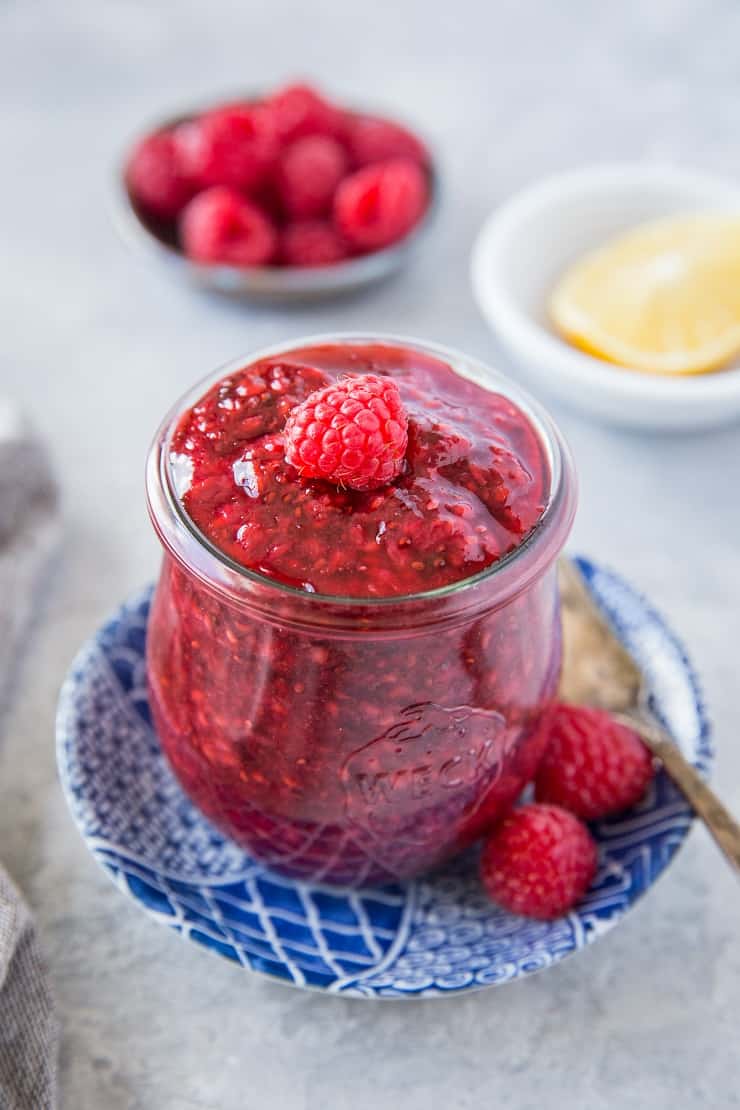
[57,559,712,998]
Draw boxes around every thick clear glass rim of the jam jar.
[146,332,576,612]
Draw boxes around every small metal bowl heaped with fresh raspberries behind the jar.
[120,83,436,300]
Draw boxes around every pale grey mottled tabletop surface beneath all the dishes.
[0,0,740,1110]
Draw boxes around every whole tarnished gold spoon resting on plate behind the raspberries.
[558,558,740,876]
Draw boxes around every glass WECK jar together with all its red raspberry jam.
[148,336,575,885]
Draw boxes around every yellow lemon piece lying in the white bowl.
[549,212,740,374]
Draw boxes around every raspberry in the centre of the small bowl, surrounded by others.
[277,135,347,220]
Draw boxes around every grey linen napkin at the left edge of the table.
[0,400,58,1110]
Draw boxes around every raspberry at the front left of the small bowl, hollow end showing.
[180,188,277,266]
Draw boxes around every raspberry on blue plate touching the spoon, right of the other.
[535,705,653,820]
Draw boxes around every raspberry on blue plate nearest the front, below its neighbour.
[480,804,598,921]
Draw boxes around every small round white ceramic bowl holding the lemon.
[472,163,740,430]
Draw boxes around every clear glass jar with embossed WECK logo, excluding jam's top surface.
[146,335,576,886]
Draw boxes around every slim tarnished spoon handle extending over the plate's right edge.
[614,714,740,878]
